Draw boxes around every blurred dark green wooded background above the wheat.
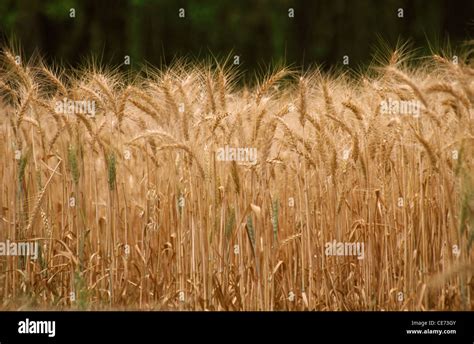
[0,0,474,70]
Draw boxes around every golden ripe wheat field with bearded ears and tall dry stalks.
[0,44,474,310]
